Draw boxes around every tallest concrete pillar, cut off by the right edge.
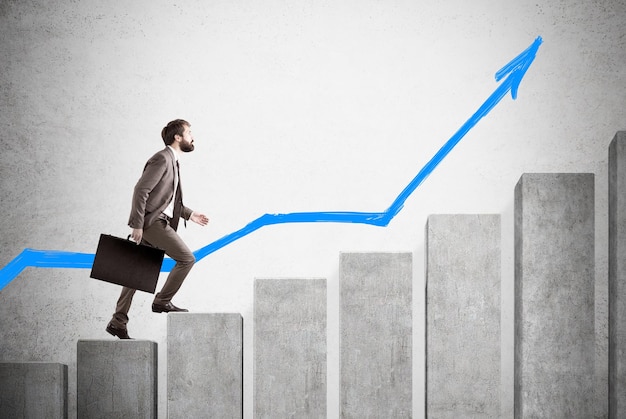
[609,131,626,419]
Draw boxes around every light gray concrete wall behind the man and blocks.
[0,0,626,418]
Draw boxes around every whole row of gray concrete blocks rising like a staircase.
[0,132,626,419]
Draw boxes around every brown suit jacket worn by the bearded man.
[128,147,192,229]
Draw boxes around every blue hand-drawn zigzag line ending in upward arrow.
[0,36,543,290]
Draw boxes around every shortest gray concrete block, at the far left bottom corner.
[0,362,67,419]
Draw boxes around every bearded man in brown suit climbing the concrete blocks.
[106,119,209,339]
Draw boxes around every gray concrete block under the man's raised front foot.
[167,313,243,419]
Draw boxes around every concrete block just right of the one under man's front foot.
[254,279,327,419]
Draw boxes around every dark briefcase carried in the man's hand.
[90,234,164,294]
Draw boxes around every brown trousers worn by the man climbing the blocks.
[111,219,196,328]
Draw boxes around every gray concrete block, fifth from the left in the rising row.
[339,253,413,419]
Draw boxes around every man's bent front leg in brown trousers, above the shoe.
[143,220,196,306]
